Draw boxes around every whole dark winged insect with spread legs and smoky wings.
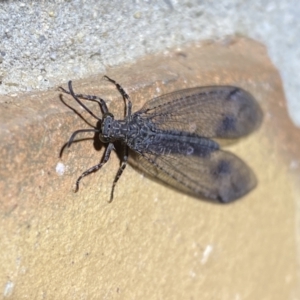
[61,76,263,203]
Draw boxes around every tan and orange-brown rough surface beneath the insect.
[0,39,300,300]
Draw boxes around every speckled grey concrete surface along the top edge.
[0,0,300,126]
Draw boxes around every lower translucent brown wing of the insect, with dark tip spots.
[129,150,257,203]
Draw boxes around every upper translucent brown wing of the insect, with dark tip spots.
[135,86,262,138]
